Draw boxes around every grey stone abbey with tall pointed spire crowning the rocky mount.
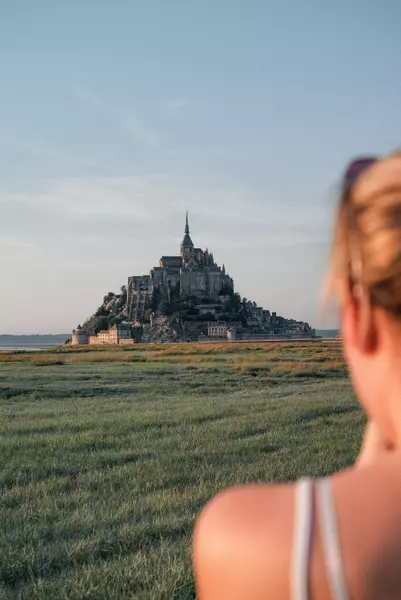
[127,213,234,321]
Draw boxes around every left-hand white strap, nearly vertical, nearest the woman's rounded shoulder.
[291,478,313,600]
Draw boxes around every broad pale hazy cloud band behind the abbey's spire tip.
[0,174,328,253]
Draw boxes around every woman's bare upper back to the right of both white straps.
[324,456,401,599]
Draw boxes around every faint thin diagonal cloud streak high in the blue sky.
[72,86,160,148]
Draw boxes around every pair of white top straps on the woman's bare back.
[291,479,349,600]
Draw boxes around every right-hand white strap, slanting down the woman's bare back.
[316,478,349,600]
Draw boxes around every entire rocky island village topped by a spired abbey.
[69,213,315,345]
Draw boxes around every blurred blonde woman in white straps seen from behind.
[194,154,401,600]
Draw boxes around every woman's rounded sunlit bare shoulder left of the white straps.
[193,485,294,600]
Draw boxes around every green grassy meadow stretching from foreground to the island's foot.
[0,343,363,600]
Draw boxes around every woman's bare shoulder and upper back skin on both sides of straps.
[193,457,401,600]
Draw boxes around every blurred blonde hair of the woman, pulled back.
[328,152,401,316]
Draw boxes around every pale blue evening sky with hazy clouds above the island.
[0,0,401,334]
